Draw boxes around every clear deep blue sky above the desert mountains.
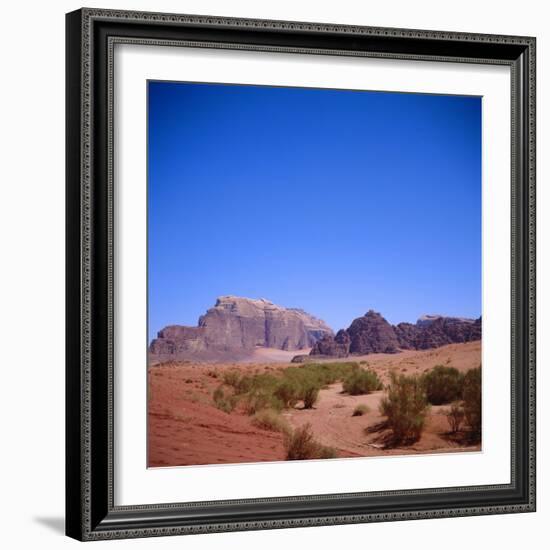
[148,82,481,338]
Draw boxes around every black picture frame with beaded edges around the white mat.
[66,9,536,540]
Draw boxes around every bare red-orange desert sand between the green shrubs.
[148,342,481,467]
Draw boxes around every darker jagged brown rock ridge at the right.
[310,310,481,357]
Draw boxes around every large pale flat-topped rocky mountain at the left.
[149,296,333,360]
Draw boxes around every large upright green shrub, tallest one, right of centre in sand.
[380,372,429,444]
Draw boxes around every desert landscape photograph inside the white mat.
[148,81,483,468]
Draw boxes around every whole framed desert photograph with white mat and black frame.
[66,9,536,540]
